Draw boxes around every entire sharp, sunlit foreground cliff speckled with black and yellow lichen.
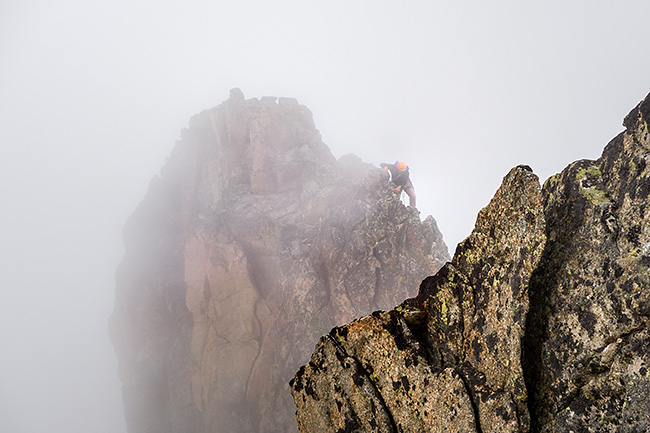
[291,96,650,433]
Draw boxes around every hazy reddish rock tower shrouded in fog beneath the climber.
[111,89,449,433]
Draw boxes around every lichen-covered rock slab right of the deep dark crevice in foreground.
[526,93,650,432]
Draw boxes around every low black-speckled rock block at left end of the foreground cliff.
[291,311,474,432]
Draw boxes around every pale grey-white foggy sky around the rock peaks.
[0,0,650,433]
